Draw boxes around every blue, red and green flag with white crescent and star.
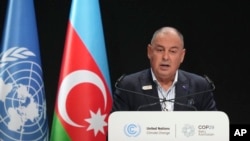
[50,0,112,141]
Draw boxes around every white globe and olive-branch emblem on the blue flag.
[0,47,48,141]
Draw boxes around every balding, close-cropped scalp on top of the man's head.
[151,26,184,47]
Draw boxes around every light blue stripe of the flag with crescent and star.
[70,0,111,90]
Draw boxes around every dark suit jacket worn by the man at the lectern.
[112,69,217,112]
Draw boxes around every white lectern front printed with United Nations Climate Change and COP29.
[108,111,230,141]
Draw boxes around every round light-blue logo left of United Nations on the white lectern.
[124,123,141,137]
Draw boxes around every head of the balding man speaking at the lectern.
[147,27,186,81]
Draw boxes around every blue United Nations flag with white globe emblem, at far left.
[0,0,49,141]
